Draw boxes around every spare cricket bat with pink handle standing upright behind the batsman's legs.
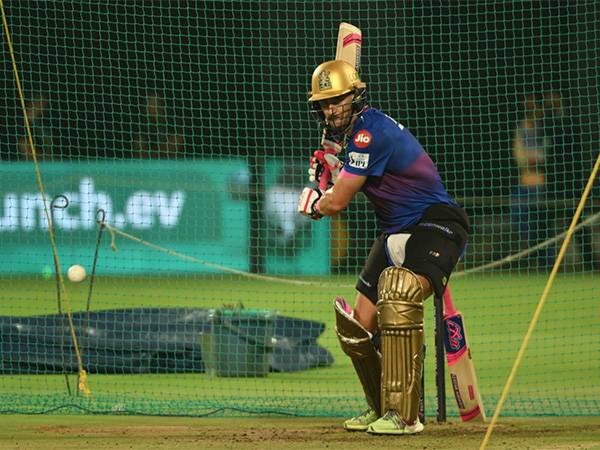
[443,287,485,422]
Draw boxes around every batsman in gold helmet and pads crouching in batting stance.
[298,60,469,435]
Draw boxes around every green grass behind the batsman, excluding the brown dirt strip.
[0,272,600,416]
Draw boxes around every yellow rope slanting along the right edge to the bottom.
[479,153,600,450]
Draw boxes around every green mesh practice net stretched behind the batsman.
[0,0,600,416]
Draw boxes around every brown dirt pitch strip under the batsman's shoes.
[0,415,600,450]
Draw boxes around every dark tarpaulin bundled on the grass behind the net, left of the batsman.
[0,308,333,374]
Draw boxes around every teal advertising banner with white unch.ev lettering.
[0,159,329,275]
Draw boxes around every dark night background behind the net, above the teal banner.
[0,0,600,271]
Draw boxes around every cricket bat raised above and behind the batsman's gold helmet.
[315,22,362,191]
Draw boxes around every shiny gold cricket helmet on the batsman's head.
[308,59,367,102]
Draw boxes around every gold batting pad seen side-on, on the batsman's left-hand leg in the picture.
[333,299,381,415]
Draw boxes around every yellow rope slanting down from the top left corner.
[0,0,90,395]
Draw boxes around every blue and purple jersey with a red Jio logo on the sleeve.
[343,108,456,234]
